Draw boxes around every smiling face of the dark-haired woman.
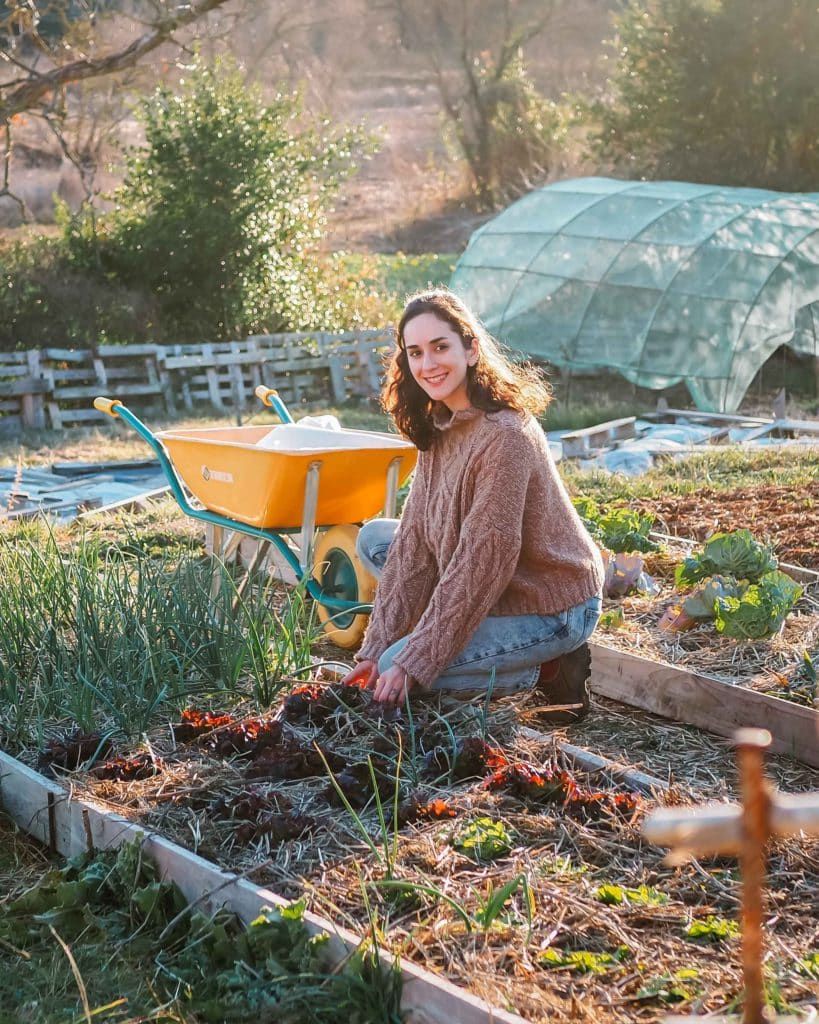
[403,313,478,413]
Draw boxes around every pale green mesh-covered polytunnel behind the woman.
[451,177,819,412]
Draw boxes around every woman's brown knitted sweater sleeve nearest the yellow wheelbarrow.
[355,454,438,662]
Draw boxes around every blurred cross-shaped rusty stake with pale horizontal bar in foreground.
[643,729,819,1024]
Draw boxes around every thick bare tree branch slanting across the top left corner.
[0,0,235,123]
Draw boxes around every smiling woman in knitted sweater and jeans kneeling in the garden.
[347,291,603,722]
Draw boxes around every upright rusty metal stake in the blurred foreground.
[736,729,771,1024]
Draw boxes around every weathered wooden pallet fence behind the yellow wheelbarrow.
[0,330,391,434]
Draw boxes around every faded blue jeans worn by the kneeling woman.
[357,519,602,696]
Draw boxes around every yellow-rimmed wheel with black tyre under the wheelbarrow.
[313,523,376,648]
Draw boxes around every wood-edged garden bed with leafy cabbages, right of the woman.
[576,499,819,767]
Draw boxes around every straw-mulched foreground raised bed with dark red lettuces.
[3,690,819,1021]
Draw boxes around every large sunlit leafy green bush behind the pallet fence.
[61,58,364,341]
